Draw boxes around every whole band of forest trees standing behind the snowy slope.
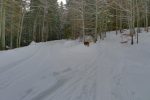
[0,0,150,50]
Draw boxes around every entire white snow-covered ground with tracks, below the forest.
[0,32,150,100]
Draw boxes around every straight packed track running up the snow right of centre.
[96,43,117,100]
